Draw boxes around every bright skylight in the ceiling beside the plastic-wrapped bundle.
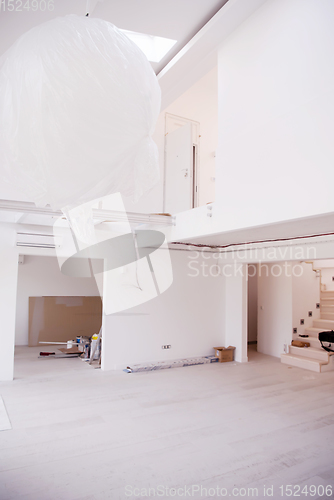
[120,29,176,62]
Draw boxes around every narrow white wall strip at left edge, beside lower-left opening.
[0,224,18,381]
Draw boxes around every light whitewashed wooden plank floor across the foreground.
[0,347,334,500]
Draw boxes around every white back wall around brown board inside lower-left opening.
[15,255,99,345]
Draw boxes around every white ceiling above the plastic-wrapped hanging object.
[0,0,228,73]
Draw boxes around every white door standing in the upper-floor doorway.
[164,123,194,214]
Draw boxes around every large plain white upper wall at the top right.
[216,0,334,226]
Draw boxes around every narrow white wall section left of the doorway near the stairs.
[225,264,248,363]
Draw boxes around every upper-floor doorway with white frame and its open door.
[164,113,200,214]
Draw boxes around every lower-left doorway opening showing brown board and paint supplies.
[14,254,102,379]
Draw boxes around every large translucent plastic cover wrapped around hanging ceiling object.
[0,15,161,211]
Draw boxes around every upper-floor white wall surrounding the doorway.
[124,68,218,213]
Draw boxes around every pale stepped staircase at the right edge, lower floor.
[281,290,334,373]
